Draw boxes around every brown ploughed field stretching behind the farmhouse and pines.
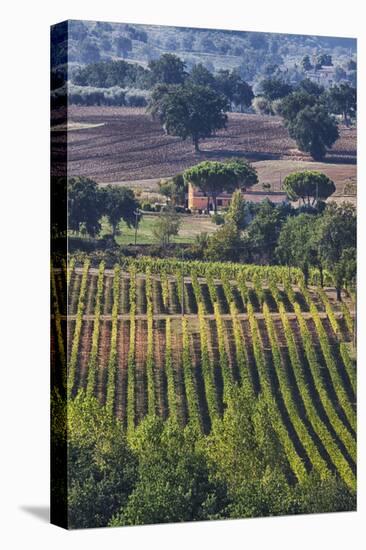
[52,105,356,191]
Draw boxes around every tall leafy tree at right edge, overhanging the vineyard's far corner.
[318,203,356,300]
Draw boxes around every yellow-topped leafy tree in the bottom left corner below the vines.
[65,394,137,529]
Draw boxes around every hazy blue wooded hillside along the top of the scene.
[53,21,356,82]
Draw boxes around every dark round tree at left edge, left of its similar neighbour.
[67,177,103,236]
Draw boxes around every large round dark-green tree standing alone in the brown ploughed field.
[149,84,229,151]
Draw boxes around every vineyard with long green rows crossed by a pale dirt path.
[51,258,356,488]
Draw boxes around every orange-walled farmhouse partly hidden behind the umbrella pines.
[187,183,288,211]
